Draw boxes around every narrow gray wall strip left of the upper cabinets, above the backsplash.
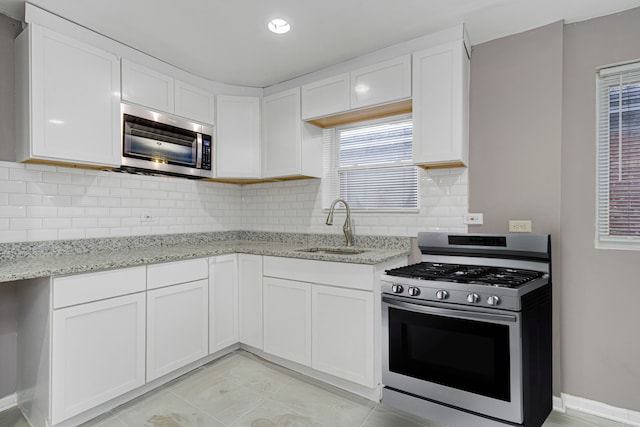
[0,14,22,161]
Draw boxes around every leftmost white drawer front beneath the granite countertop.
[53,266,146,309]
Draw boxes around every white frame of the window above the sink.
[322,113,421,214]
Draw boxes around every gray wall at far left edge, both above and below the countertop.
[0,14,22,399]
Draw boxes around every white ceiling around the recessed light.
[0,0,640,87]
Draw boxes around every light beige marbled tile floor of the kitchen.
[0,351,636,427]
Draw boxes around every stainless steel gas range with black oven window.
[382,233,552,427]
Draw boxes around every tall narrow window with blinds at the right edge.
[596,59,640,249]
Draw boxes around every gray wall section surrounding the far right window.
[561,8,640,411]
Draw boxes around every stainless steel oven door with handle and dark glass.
[382,295,523,423]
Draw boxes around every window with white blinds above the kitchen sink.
[323,116,418,210]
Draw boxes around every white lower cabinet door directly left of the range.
[311,285,375,387]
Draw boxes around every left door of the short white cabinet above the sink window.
[301,73,351,120]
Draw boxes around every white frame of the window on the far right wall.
[594,60,640,250]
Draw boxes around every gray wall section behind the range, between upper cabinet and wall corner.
[469,22,563,395]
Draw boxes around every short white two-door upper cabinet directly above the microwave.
[122,59,215,124]
